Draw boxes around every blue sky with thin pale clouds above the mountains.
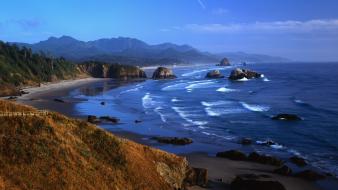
[0,0,338,61]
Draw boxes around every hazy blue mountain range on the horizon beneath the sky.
[14,36,289,66]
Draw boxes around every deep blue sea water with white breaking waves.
[72,63,338,177]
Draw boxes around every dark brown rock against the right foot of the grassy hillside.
[184,168,208,187]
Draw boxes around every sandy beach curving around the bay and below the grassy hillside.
[13,78,336,190]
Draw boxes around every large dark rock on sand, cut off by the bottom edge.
[230,174,285,190]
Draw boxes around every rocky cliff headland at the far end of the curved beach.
[78,62,147,79]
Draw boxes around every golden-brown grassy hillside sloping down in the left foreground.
[0,100,188,190]
